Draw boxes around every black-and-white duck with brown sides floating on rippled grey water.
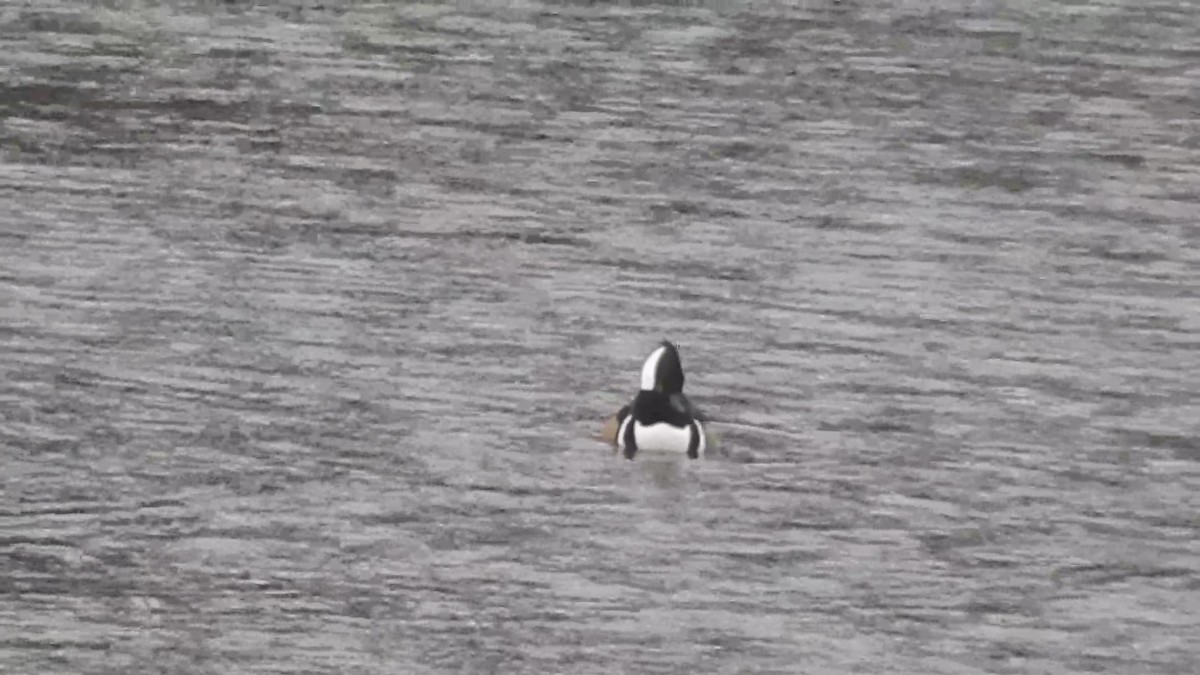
[601,340,709,460]
